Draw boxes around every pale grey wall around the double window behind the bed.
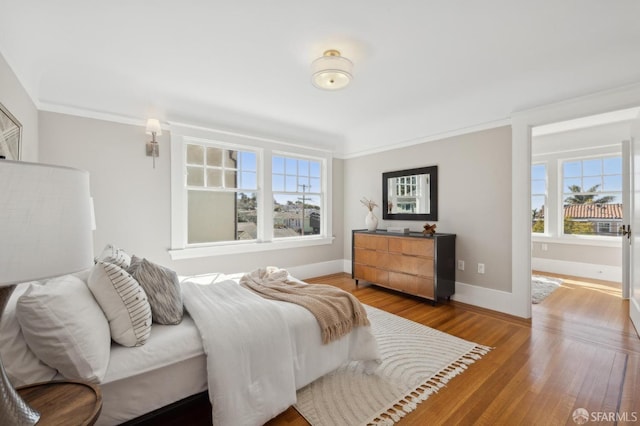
[40,112,343,278]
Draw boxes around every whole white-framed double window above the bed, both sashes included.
[169,124,333,260]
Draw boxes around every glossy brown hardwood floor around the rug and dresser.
[268,274,640,426]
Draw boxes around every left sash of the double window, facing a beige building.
[185,143,259,244]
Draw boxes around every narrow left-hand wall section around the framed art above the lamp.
[0,54,38,162]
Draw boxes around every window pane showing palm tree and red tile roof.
[562,156,622,236]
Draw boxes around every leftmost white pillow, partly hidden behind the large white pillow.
[0,281,57,386]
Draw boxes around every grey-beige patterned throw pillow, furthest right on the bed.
[127,256,184,325]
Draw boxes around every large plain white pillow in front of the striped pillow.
[16,275,111,383]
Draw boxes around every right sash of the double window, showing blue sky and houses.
[272,155,323,238]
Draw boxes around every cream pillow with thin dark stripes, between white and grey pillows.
[89,261,151,346]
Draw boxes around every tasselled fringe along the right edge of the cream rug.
[367,345,493,426]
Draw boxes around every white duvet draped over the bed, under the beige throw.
[182,275,380,426]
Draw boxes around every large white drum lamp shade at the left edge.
[0,160,93,286]
